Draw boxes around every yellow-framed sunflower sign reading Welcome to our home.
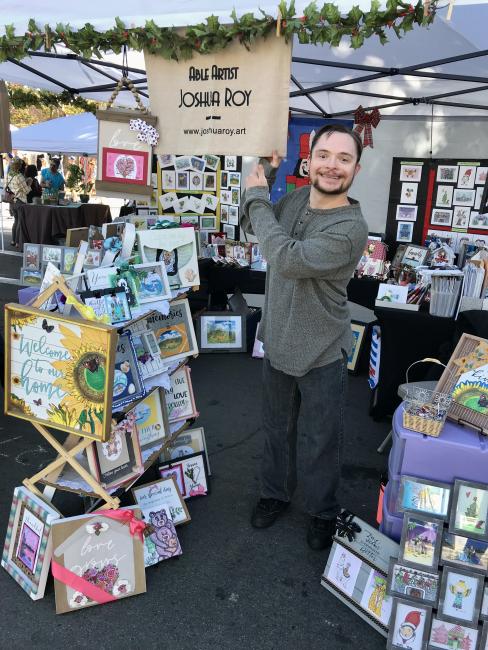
[5,304,117,442]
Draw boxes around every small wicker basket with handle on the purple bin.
[403,357,452,438]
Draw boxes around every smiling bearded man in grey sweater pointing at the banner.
[241,125,368,550]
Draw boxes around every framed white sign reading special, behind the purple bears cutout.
[132,477,191,526]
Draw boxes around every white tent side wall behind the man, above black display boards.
[351,118,488,232]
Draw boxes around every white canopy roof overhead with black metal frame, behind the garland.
[0,0,488,117]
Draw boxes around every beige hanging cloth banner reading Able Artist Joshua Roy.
[144,36,292,156]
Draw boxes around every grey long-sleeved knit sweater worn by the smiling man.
[241,166,368,377]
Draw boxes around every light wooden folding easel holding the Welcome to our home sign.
[22,277,120,510]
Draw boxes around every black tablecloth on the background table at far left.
[15,203,112,250]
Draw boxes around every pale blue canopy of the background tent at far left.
[12,113,98,155]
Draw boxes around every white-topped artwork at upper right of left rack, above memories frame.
[137,228,200,289]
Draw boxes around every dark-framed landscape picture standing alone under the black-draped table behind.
[197,311,247,352]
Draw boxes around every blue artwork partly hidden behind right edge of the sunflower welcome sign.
[112,332,146,411]
